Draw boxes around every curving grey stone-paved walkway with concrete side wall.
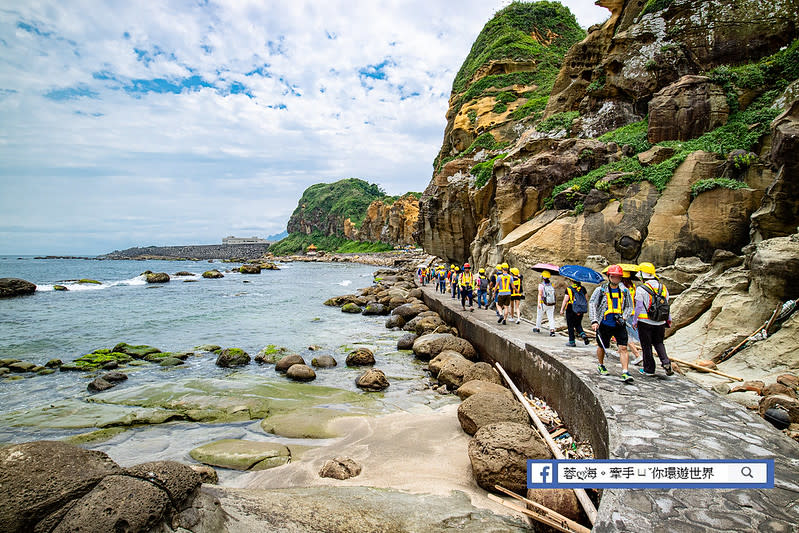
[423,286,799,533]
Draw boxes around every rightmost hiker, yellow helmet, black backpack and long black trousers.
[633,263,674,376]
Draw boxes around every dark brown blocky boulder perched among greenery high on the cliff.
[647,75,730,144]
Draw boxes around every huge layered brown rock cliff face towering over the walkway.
[417,0,799,266]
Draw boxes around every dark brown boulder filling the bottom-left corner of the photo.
[0,441,122,531]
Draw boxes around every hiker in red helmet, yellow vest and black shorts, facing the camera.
[588,265,633,383]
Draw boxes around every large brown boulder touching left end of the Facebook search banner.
[464,422,552,492]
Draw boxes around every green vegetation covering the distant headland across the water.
[284,178,386,230]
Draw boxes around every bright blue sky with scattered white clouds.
[0,0,610,255]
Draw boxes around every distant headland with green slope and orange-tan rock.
[287,179,419,245]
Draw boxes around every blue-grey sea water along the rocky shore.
[0,256,446,472]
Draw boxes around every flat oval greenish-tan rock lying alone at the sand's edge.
[189,439,291,470]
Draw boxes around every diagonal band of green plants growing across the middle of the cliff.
[545,94,779,209]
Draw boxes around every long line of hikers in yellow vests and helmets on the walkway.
[424,263,674,382]
